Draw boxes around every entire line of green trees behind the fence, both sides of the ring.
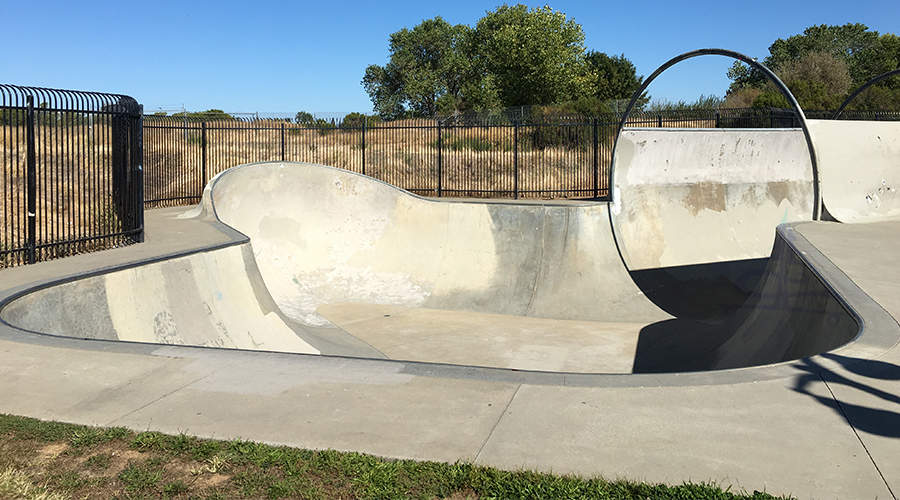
[361,5,900,120]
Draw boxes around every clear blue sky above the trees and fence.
[0,0,900,116]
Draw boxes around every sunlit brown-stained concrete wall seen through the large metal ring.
[612,128,814,270]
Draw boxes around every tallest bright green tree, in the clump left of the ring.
[472,4,596,106]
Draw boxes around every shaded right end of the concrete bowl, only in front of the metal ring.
[633,227,860,373]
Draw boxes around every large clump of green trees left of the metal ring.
[362,5,641,120]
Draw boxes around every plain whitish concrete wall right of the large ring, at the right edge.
[808,120,900,222]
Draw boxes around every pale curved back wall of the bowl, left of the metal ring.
[211,162,670,326]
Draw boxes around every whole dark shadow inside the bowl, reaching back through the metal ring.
[632,238,860,373]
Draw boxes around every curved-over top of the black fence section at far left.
[0,84,141,114]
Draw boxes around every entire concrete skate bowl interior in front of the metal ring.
[0,162,859,374]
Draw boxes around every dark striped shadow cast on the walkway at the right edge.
[793,354,900,438]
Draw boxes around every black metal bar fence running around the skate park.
[0,91,900,267]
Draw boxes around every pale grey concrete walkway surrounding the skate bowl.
[0,209,900,499]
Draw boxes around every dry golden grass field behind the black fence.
[0,112,732,266]
